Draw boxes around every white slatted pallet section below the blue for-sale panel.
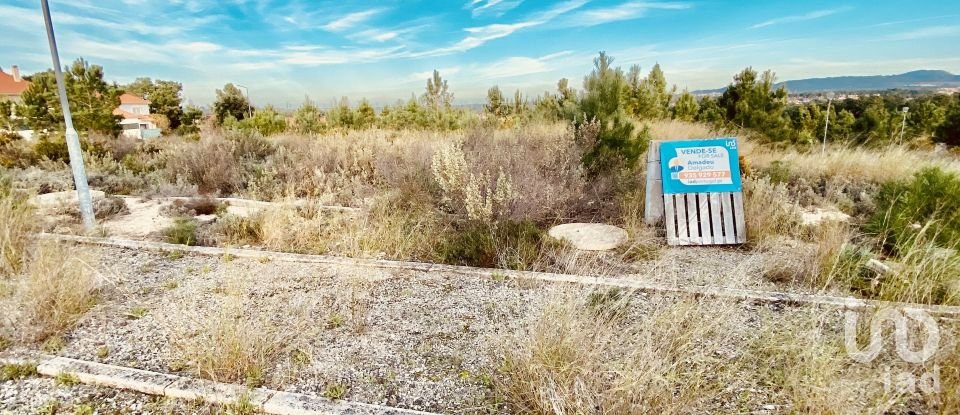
[663,192,747,245]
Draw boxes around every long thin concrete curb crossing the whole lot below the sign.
[36,233,960,317]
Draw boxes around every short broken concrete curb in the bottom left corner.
[0,356,437,415]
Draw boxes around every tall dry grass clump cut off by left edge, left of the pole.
[0,177,37,276]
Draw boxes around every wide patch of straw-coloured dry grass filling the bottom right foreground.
[496,294,936,414]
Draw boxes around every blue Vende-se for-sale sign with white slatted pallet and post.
[647,137,746,245]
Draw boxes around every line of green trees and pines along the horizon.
[0,52,960,150]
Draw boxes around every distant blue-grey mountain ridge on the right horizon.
[693,69,960,95]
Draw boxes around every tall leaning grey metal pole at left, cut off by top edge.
[40,0,96,231]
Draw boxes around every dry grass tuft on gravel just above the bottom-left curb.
[170,296,296,387]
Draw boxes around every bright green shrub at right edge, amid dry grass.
[866,167,960,255]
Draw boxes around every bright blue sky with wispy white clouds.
[0,0,960,108]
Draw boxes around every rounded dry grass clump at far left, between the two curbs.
[15,243,98,340]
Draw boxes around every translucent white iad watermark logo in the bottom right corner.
[843,308,940,394]
